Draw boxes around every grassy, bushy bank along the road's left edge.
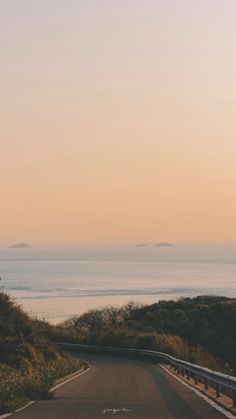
[0,292,86,414]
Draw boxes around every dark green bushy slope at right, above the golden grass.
[130,296,236,371]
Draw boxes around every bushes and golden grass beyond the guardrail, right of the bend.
[37,296,236,375]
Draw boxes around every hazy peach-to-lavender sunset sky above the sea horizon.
[0,0,236,245]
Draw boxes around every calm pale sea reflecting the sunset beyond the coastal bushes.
[0,245,236,322]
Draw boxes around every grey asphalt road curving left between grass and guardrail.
[12,354,225,419]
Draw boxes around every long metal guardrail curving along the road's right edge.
[55,342,236,408]
